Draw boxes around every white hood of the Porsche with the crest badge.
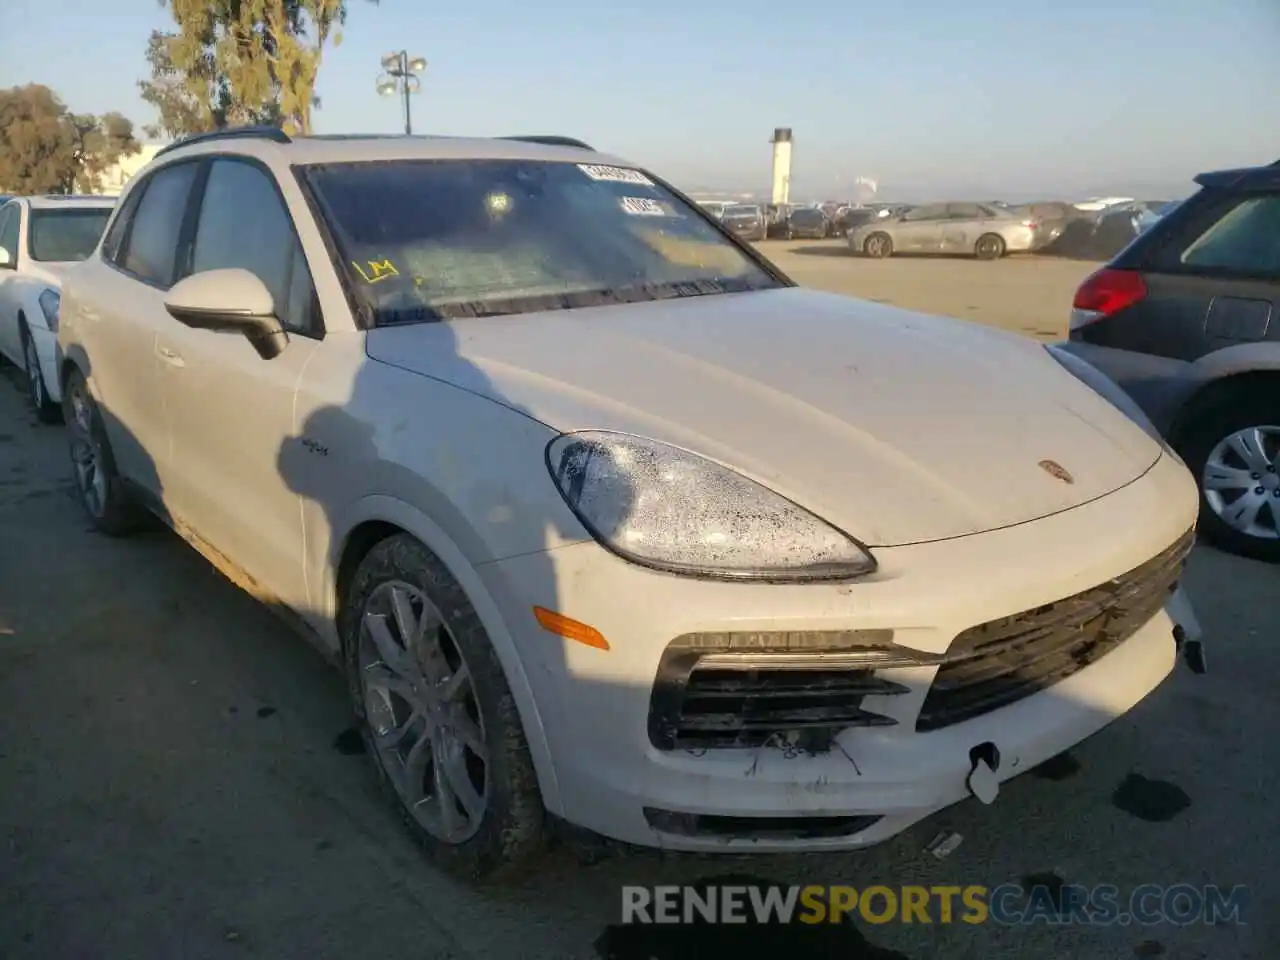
[367,288,1161,547]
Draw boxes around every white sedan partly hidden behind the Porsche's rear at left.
[0,196,115,422]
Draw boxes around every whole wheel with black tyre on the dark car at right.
[1178,385,1280,563]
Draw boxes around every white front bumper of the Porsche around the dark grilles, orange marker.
[480,458,1201,852]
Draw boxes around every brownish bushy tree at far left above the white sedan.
[0,83,140,193]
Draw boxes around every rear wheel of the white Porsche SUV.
[63,370,145,536]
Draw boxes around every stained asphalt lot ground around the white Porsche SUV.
[0,257,1280,960]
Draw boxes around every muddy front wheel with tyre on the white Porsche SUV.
[342,534,545,879]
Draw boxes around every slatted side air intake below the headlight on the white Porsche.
[649,631,915,751]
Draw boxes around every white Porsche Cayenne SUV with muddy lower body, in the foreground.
[59,129,1199,876]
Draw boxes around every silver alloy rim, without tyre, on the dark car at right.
[1201,425,1280,540]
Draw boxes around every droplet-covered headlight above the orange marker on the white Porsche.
[547,430,876,582]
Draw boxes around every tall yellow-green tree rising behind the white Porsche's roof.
[138,0,378,136]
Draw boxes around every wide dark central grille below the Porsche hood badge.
[915,532,1194,731]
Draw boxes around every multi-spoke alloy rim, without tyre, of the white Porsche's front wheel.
[357,580,490,844]
